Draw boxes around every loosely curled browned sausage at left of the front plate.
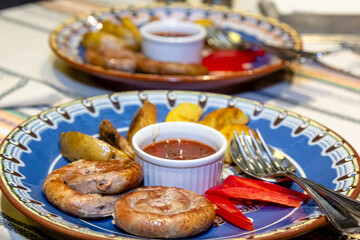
[42,160,143,219]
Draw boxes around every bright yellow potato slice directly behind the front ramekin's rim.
[165,103,203,122]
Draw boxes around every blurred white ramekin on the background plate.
[140,20,206,63]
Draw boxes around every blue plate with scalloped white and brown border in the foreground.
[0,91,360,239]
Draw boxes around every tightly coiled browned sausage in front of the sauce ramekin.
[114,186,216,238]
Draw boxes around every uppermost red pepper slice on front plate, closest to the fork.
[222,175,310,201]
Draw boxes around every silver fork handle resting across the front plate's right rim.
[286,172,360,234]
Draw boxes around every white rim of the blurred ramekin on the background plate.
[139,19,206,44]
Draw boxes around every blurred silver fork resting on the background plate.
[207,27,328,62]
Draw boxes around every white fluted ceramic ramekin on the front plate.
[132,122,227,194]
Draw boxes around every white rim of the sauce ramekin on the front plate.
[132,122,227,168]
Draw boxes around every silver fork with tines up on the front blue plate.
[230,130,360,234]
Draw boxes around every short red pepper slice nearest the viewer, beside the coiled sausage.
[204,194,254,231]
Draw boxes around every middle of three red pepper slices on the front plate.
[205,185,301,207]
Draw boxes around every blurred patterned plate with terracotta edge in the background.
[50,4,301,92]
